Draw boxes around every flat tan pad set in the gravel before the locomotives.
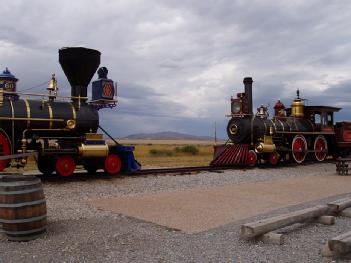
[91,176,351,233]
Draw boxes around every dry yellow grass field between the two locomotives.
[119,140,221,167]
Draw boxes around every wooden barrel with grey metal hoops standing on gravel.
[0,173,47,241]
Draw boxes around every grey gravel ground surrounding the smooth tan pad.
[0,163,351,263]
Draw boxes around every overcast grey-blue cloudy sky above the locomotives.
[0,0,351,138]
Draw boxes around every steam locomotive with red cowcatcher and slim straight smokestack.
[211,77,351,166]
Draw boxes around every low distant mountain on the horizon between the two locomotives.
[123,131,214,141]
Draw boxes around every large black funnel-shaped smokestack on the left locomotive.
[59,47,101,100]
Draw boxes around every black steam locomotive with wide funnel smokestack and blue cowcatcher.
[0,47,140,176]
